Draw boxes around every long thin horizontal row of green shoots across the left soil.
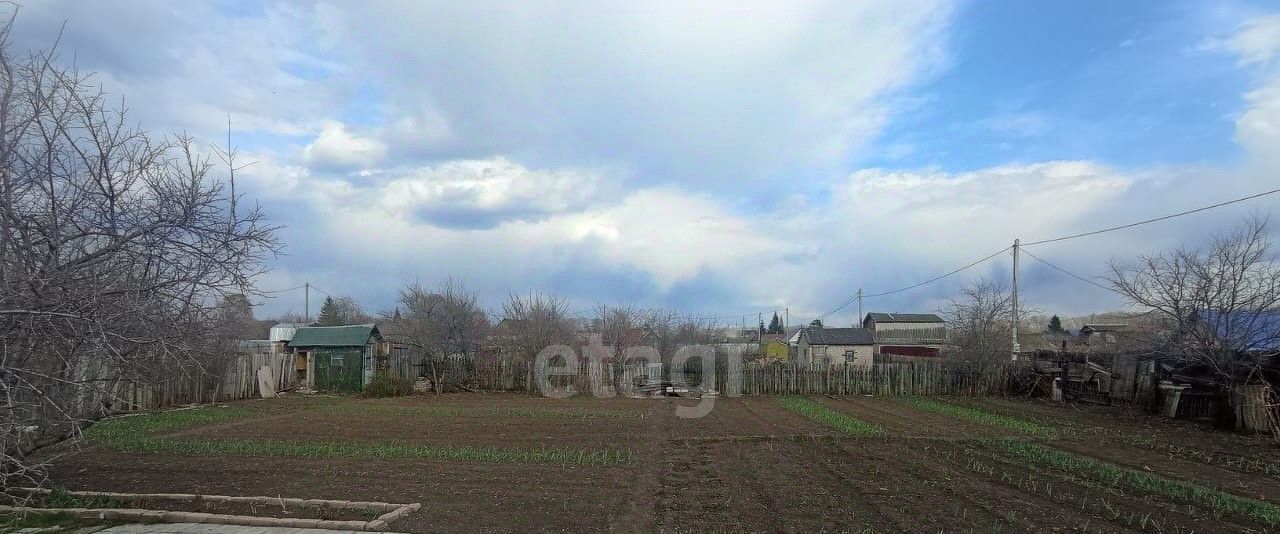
[102,438,634,466]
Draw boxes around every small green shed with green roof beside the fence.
[289,324,383,393]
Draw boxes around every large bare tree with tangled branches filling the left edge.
[0,19,278,485]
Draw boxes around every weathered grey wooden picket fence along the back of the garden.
[101,352,1029,412]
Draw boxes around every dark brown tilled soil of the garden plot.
[35,394,1280,533]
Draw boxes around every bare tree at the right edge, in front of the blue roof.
[1110,213,1280,424]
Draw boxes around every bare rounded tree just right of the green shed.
[388,278,488,394]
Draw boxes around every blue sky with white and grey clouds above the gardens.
[10,0,1280,325]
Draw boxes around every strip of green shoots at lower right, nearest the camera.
[983,439,1280,528]
